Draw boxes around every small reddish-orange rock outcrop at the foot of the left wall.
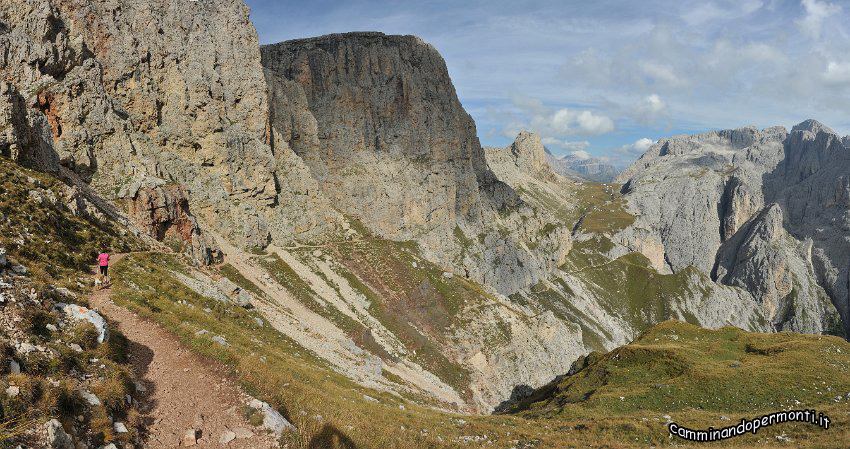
[118,178,222,265]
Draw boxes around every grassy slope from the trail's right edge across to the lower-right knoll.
[115,250,850,448]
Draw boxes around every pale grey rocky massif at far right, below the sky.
[615,120,848,332]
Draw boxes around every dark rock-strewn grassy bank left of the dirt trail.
[0,158,140,447]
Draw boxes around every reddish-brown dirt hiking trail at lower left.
[89,254,277,449]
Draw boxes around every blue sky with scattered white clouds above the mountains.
[246,0,850,166]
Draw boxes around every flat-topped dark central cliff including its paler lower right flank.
[262,33,565,293]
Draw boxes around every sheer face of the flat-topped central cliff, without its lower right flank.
[262,33,501,239]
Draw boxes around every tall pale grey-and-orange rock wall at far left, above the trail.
[0,0,276,245]
